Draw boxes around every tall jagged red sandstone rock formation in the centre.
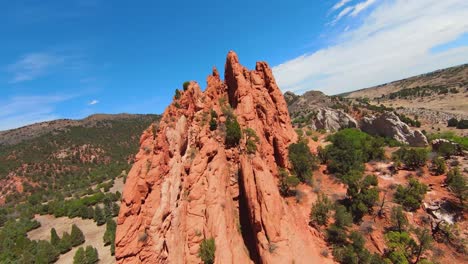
[116,52,329,263]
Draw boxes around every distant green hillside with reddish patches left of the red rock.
[0,114,160,204]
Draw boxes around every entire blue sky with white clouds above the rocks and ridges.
[0,0,468,130]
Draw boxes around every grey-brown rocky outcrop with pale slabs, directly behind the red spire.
[284,91,358,131]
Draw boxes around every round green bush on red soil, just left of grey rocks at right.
[394,178,427,211]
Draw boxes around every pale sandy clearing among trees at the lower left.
[28,215,115,264]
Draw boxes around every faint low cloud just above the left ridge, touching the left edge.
[0,95,74,130]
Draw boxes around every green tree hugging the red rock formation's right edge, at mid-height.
[288,141,318,182]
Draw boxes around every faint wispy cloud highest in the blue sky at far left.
[7,52,65,83]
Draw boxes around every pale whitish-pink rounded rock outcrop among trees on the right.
[360,112,428,147]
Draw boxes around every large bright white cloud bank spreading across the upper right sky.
[273,0,468,94]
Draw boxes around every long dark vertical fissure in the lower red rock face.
[239,167,261,263]
